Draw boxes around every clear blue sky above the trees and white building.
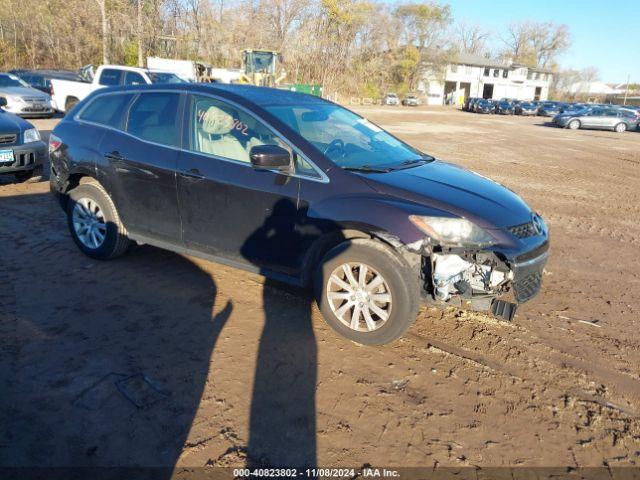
[439,0,640,83]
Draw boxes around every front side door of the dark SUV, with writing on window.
[178,95,300,275]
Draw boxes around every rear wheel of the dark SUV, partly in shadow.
[67,183,131,260]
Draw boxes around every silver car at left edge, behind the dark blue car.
[0,73,55,117]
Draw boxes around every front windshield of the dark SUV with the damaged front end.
[265,103,432,171]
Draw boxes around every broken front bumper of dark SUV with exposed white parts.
[413,237,549,320]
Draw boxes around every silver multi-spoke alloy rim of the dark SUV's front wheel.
[327,263,393,332]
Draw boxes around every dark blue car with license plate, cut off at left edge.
[0,98,47,182]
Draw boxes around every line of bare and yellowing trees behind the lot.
[0,0,588,97]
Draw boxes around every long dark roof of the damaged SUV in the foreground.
[97,83,331,107]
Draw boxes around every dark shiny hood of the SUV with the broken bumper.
[362,160,532,229]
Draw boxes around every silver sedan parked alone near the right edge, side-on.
[553,107,638,133]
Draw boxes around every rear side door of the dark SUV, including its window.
[100,92,181,243]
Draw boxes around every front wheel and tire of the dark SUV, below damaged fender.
[314,239,420,345]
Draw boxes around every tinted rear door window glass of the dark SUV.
[127,92,180,146]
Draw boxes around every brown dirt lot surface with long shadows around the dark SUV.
[0,107,640,467]
